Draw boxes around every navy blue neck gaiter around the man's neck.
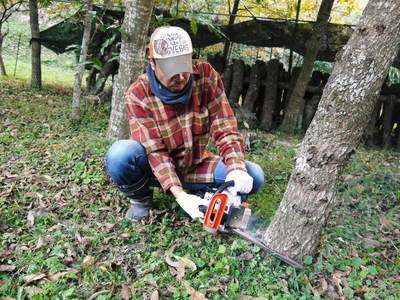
[146,64,193,104]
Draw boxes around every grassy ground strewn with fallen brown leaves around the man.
[0,77,400,300]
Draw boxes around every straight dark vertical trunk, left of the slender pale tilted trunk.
[29,0,42,89]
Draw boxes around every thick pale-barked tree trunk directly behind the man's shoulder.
[107,0,154,141]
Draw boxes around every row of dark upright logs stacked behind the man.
[216,58,400,151]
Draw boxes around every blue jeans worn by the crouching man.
[106,140,264,199]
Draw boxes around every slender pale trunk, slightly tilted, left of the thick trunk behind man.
[71,0,93,123]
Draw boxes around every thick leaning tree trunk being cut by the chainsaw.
[264,0,400,260]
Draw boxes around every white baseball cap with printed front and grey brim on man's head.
[149,26,193,79]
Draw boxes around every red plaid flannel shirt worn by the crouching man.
[126,60,246,191]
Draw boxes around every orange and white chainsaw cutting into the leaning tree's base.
[200,181,304,269]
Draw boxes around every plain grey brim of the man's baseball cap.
[155,54,192,79]
